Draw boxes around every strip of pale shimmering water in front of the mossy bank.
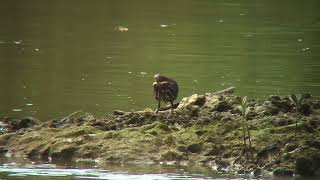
[0,157,319,180]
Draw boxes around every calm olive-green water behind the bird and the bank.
[0,0,320,121]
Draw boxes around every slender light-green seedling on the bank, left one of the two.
[238,96,252,160]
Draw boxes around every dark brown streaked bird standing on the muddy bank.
[153,74,179,113]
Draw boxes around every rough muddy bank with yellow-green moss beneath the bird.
[0,88,320,175]
